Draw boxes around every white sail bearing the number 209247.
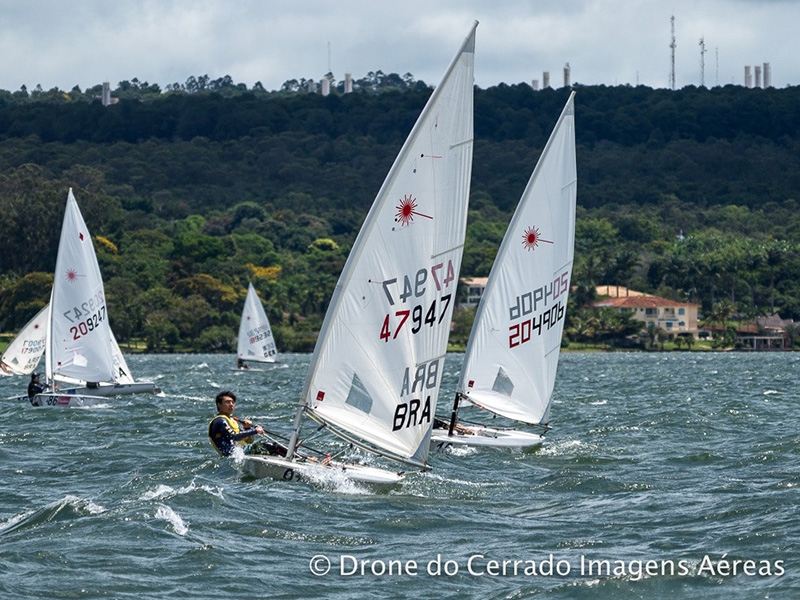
[47,188,114,382]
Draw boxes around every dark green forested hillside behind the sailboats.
[0,81,800,351]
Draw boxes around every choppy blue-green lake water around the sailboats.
[0,353,800,600]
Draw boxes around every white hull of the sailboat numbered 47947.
[236,456,403,486]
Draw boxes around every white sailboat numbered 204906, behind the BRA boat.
[431,92,577,450]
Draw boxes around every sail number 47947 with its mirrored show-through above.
[380,260,456,342]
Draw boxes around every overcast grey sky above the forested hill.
[0,0,800,91]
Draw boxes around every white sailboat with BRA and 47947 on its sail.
[236,22,478,484]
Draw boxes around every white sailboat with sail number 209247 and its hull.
[25,188,160,406]
